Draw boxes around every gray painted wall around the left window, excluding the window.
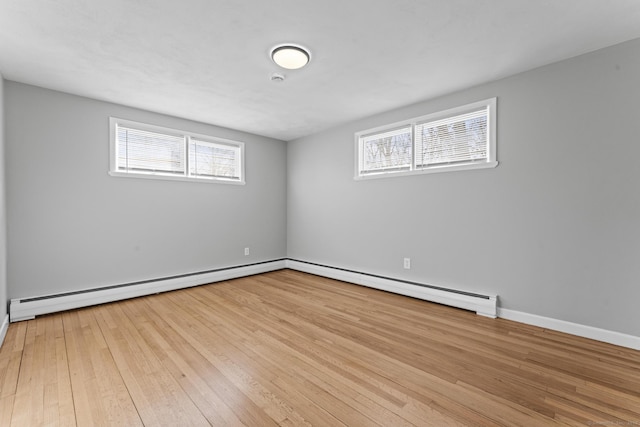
[5,82,286,298]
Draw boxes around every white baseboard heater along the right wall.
[286,259,498,318]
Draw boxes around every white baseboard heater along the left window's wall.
[9,260,285,322]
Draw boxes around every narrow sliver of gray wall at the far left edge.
[0,74,7,323]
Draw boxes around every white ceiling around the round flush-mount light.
[0,0,640,140]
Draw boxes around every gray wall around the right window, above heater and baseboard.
[287,40,640,336]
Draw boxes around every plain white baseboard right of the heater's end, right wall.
[498,308,640,350]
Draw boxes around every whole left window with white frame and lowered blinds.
[109,117,244,184]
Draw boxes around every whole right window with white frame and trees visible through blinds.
[355,98,498,179]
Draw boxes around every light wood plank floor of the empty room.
[0,270,640,427]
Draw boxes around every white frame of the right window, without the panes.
[354,98,498,180]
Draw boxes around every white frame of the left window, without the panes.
[109,117,245,185]
